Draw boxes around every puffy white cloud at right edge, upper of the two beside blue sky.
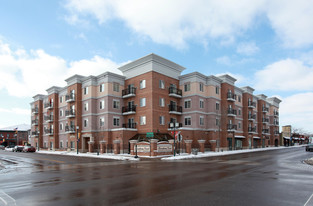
[254,59,313,91]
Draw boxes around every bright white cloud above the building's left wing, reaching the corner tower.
[0,41,121,97]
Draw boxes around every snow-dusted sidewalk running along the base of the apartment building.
[37,145,313,161]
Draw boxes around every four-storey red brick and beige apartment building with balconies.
[31,54,281,153]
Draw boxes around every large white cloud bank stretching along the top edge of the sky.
[65,0,313,49]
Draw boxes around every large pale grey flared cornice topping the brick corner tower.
[118,53,185,79]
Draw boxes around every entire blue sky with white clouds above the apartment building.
[0,0,313,132]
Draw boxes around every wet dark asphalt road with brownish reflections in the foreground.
[0,148,313,206]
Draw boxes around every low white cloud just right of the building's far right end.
[279,92,313,133]
